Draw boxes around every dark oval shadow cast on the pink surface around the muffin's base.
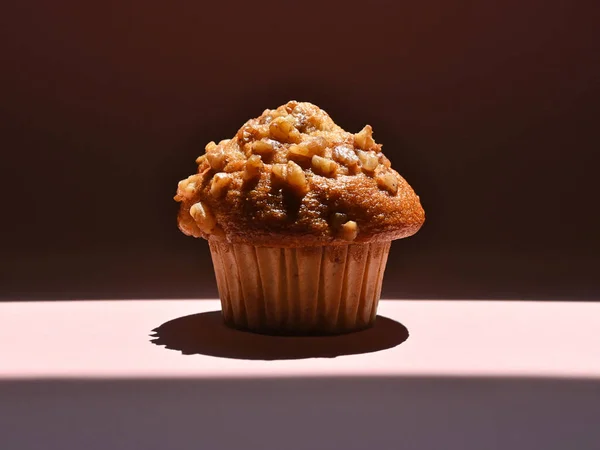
[151,311,408,360]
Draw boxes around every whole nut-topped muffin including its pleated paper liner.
[175,101,425,334]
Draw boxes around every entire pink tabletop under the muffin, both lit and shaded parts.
[0,300,600,450]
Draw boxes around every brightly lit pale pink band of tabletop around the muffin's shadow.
[0,300,600,379]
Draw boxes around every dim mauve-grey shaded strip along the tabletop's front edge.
[0,373,600,450]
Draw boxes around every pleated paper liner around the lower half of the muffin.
[209,239,391,334]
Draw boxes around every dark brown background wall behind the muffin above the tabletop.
[0,0,600,299]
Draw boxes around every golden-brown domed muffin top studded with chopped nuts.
[175,101,425,247]
